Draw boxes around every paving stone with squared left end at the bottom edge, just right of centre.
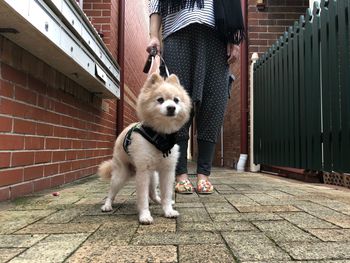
[179,245,236,263]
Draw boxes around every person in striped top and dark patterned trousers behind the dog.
[147,0,245,194]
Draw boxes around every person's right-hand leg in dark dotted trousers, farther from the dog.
[196,25,229,190]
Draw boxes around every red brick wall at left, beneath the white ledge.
[0,36,116,200]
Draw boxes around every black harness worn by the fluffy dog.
[123,123,177,158]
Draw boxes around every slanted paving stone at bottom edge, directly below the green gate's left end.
[223,231,290,262]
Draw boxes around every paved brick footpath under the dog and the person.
[0,168,350,263]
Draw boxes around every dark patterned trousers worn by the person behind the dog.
[163,24,229,175]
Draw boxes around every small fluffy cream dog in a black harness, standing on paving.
[98,73,191,224]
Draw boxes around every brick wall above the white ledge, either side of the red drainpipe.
[83,0,148,126]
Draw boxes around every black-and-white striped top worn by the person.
[149,0,215,39]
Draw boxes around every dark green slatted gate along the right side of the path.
[254,0,350,172]
